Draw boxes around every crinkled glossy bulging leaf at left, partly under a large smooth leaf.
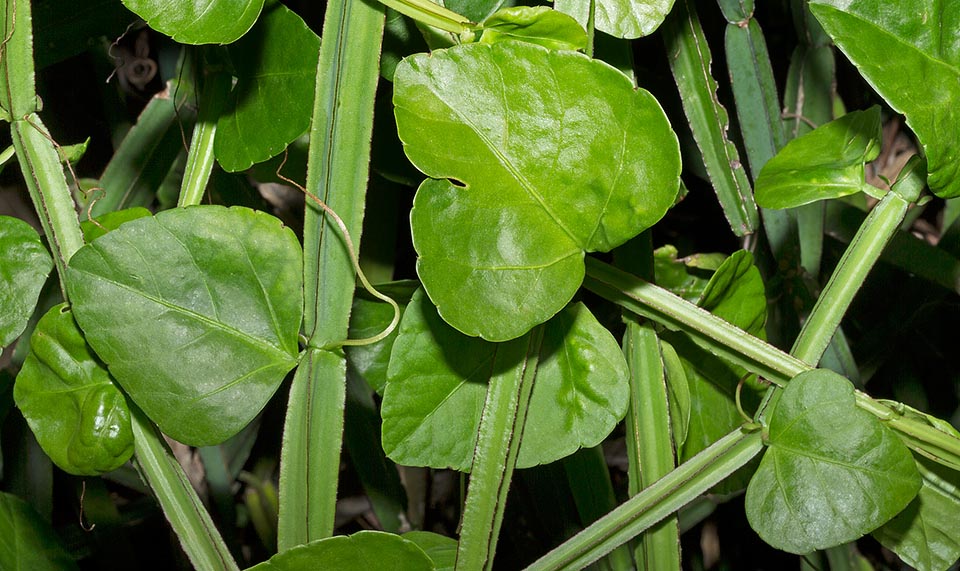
[13,304,133,476]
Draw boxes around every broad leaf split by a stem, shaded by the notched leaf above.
[382,291,629,471]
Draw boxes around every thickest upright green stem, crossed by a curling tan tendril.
[278,2,384,551]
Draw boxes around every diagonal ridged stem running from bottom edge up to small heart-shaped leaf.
[527,429,763,571]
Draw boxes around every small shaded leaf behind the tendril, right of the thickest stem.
[343,280,420,395]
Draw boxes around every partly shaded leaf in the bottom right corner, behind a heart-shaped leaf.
[872,458,960,571]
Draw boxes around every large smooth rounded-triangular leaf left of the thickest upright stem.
[67,206,303,446]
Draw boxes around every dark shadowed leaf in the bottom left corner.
[0,492,77,571]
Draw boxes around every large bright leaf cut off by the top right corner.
[810,0,960,198]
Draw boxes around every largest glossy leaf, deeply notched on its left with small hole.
[394,42,680,341]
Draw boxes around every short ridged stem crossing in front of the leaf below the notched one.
[456,327,543,571]
